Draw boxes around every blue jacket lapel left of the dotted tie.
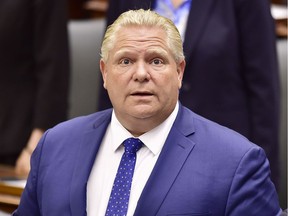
[70,110,111,216]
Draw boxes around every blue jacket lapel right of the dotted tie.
[134,106,195,216]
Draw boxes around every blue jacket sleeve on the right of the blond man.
[225,147,281,216]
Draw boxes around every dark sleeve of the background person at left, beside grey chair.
[33,0,69,129]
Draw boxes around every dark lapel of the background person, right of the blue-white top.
[184,0,216,61]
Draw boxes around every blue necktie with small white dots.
[105,138,143,216]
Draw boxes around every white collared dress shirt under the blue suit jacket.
[87,103,179,216]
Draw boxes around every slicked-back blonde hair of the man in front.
[101,9,184,62]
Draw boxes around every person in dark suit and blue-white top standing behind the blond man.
[98,0,280,186]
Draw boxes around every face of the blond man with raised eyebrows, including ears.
[100,26,185,133]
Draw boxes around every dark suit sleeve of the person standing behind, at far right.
[235,0,280,184]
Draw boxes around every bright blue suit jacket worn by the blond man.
[14,105,280,216]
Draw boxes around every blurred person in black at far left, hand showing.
[0,0,69,175]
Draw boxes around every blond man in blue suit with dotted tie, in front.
[13,10,281,216]
